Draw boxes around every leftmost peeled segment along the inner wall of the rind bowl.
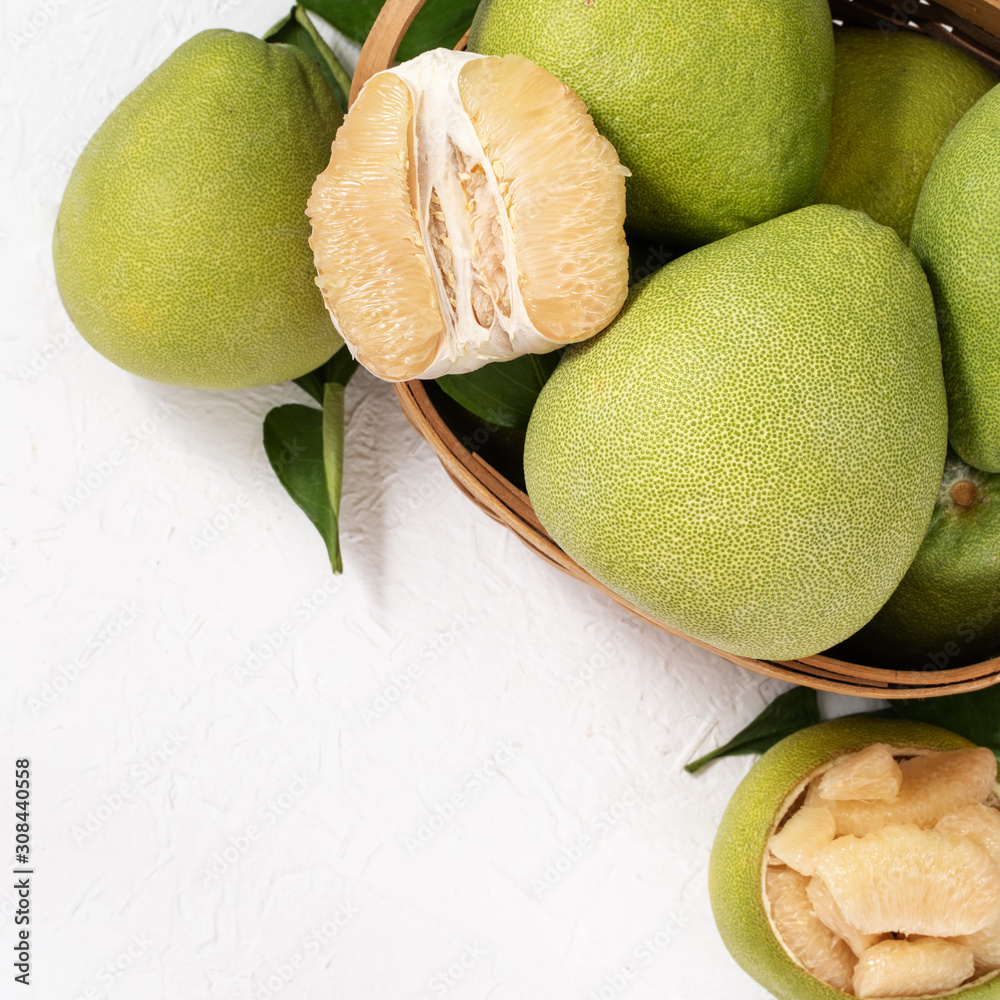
[764,867,855,990]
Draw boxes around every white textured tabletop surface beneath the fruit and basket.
[0,0,876,1000]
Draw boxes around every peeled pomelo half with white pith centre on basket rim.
[306,49,628,381]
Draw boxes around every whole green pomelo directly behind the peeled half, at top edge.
[469,0,833,246]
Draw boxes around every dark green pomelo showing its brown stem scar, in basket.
[839,453,1000,670]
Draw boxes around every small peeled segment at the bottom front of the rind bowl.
[854,938,975,997]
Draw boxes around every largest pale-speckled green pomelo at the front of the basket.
[524,205,947,660]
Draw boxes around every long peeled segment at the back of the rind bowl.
[806,747,997,837]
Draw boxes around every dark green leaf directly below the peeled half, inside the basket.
[437,351,560,430]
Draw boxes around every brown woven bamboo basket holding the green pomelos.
[351,0,1000,698]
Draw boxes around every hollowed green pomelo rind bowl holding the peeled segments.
[708,718,1000,1000]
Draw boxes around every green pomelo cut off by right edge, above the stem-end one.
[910,86,1000,472]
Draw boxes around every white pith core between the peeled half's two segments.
[362,49,562,378]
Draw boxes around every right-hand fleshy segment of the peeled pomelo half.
[458,56,628,344]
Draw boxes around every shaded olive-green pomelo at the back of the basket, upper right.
[816,28,997,243]
